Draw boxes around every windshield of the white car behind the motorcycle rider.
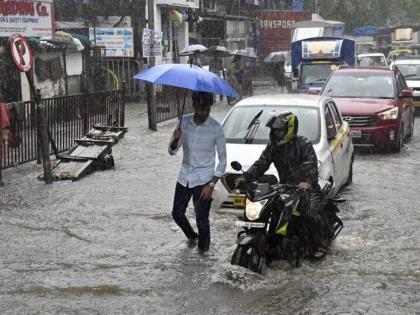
[223,105,320,144]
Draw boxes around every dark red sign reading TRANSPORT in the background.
[255,10,311,57]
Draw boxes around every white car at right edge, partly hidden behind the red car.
[391,56,420,112]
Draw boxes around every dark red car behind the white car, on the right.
[321,68,414,152]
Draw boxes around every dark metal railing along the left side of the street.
[0,90,125,169]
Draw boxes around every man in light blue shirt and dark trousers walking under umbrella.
[168,92,227,253]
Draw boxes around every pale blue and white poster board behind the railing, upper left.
[89,27,134,57]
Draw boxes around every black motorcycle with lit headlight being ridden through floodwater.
[231,162,344,273]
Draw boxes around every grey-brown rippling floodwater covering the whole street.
[0,87,420,314]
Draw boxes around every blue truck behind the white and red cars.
[291,36,356,93]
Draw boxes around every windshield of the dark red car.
[322,72,395,98]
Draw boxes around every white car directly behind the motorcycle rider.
[212,94,353,214]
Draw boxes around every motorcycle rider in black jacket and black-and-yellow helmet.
[235,112,326,258]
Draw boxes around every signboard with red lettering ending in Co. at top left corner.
[0,0,54,37]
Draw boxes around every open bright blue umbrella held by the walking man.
[133,63,239,126]
